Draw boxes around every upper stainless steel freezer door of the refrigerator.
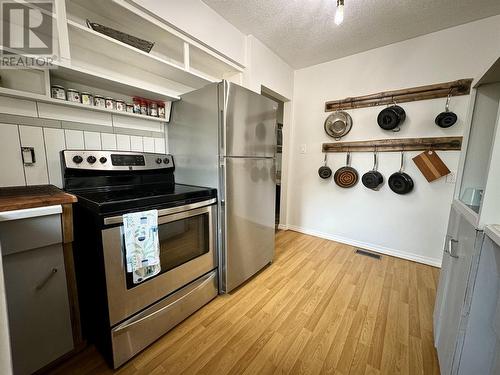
[223,81,278,157]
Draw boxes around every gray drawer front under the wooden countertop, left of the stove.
[0,214,62,255]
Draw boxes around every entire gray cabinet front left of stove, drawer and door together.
[0,209,74,374]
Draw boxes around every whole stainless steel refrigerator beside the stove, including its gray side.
[168,81,277,293]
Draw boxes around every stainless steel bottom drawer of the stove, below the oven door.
[111,270,218,368]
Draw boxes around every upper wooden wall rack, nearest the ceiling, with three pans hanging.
[325,78,472,112]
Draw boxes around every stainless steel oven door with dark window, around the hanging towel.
[102,200,217,326]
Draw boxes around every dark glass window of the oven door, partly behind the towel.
[127,212,210,289]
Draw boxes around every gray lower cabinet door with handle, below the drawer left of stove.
[2,243,73,374]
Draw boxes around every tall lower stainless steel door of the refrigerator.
[221,158,276,292]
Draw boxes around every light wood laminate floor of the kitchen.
[48,231,439,375]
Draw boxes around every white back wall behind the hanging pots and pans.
[288,16,500,265]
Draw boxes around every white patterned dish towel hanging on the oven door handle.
[123,210,161,284]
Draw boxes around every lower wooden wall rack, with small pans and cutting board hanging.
[323,137,462,152]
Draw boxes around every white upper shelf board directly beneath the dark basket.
[68,20,215,89]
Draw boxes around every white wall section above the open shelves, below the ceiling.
[134,0,245,65]
